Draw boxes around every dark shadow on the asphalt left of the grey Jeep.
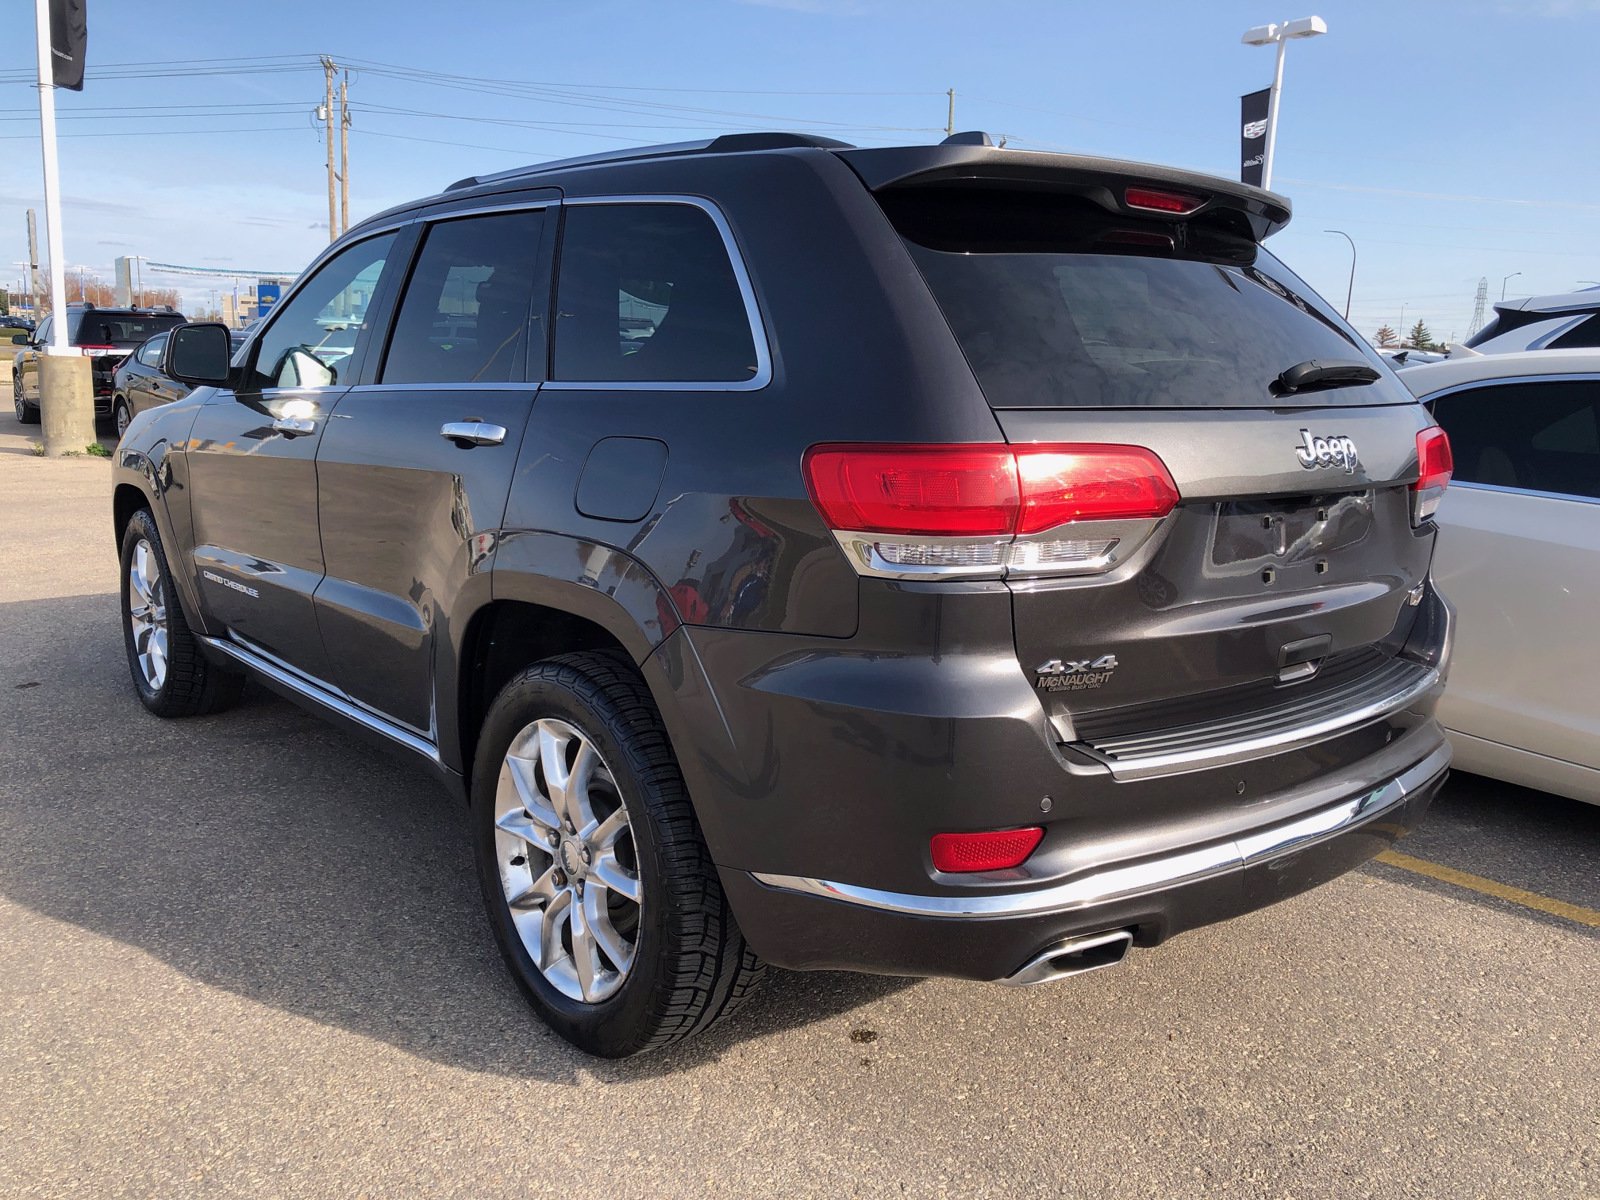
[0,594,912,1082]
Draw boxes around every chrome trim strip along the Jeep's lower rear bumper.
[750,744,1450,918]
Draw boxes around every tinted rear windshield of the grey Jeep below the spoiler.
[880,189,1410,408]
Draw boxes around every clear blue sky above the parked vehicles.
[0,0,1600,338]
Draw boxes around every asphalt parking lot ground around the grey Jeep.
[0,390,1600,1197]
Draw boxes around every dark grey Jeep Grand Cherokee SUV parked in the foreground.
[112,134,1450,1056]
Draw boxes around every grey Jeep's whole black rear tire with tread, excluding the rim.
[472,651,765,1058]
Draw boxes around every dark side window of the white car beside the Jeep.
[1434,379,1600,499]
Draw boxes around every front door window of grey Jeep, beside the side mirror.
[250,234,395,390]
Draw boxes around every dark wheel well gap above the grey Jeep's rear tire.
[456,600,634,776]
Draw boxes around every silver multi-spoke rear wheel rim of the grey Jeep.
[494,718,643,1003]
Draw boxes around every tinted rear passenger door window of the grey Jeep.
[381,211,544,384]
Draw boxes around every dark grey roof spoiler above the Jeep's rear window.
[834,146,1291,242]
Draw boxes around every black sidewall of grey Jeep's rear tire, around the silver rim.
[472,662,669,1058]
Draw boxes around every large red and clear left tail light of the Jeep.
[805,443,1178,578]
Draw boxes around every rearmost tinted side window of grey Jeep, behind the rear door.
[554,203,757,382]
